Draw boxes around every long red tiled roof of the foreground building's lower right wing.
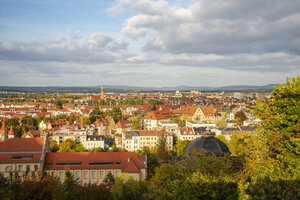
[45,152,146,171]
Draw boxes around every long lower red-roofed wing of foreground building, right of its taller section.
[45,152,147,186]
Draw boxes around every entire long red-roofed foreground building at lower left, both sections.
[0,136,147,186]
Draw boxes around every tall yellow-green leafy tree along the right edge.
[244,76,300,199]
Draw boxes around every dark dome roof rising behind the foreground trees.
[186,137,231,156]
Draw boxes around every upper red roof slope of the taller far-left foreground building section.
[0,138,44,152]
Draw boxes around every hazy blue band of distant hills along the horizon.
[0,84,276,93]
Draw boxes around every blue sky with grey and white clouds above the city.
[0,0,300,87]
